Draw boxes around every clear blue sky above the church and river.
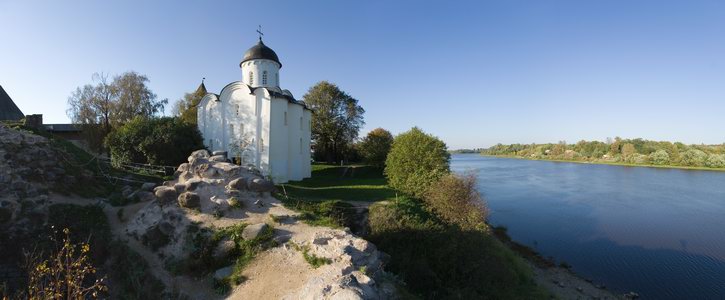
[0,0,725,148]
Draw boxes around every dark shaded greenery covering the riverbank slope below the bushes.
[369,199,549,299]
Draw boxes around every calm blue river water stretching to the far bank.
[451,154,725,299]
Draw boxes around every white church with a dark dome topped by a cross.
[197,36,312,183]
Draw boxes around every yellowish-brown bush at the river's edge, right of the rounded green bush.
[423,174,487,230]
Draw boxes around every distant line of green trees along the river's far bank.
[481,137,725,168]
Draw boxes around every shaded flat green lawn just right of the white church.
[280,164,395,202]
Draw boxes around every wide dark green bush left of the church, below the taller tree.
[106,117,204,166]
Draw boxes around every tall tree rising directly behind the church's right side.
[304,81,365,163]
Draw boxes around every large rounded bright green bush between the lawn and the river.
[385,127,451,197]
